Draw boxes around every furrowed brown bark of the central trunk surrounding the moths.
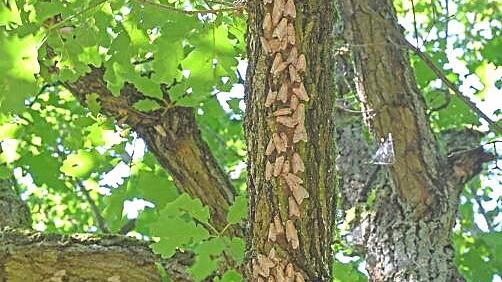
[245,0,336,281]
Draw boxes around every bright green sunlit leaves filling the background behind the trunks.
[0,0,502,281]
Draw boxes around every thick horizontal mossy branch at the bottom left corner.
[0,229,193,282]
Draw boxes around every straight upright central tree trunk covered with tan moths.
[245,0,336,281]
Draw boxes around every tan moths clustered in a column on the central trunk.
[253,0,310,281]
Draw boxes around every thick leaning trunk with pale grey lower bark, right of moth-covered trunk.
[337,0,493,281]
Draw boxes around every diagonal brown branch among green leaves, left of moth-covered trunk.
[64,68,241,234]
